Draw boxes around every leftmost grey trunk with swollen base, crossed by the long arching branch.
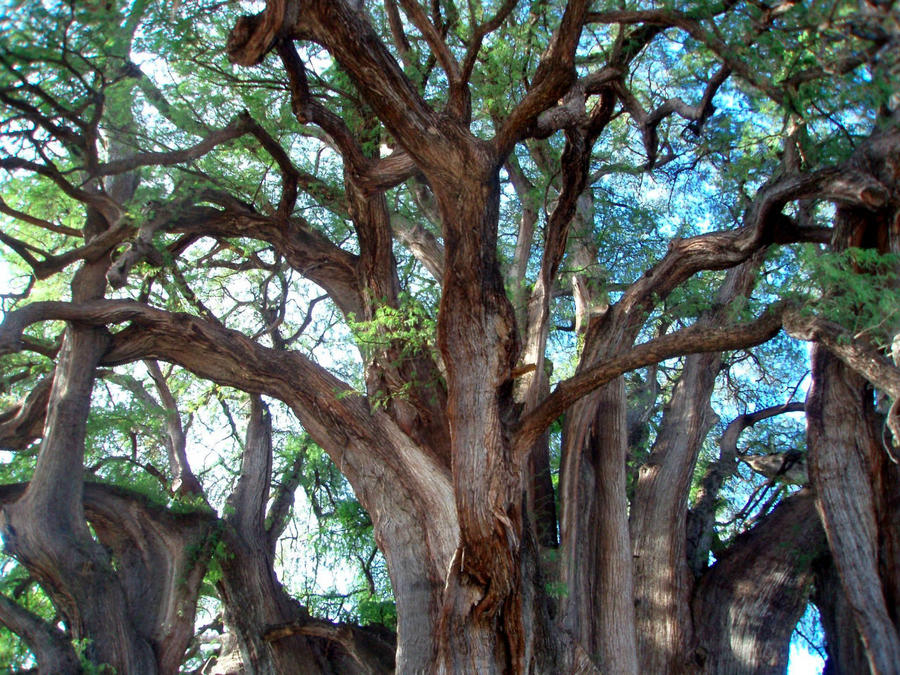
[2,247,160,672]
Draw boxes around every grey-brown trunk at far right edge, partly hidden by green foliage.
[807,127,900,673]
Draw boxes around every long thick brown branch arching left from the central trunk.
[0,300,432,480]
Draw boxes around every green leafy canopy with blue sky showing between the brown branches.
[0,0,900,672]
